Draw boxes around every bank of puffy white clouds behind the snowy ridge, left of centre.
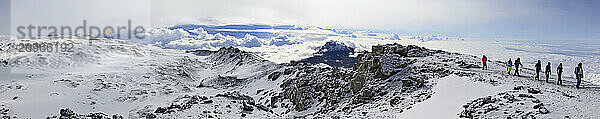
[148,28,302,50]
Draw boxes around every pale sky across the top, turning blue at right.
[0,0,600,41]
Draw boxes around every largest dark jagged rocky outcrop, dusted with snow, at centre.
[268,44,451,117]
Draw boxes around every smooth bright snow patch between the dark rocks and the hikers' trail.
[399,75,506,119]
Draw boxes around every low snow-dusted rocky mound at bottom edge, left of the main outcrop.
[135,91,274,118]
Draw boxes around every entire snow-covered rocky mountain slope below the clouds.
[0,39,600,118]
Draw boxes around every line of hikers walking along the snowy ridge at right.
[481,55,583,88]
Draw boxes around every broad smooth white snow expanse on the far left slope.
[0,39,200,118]
